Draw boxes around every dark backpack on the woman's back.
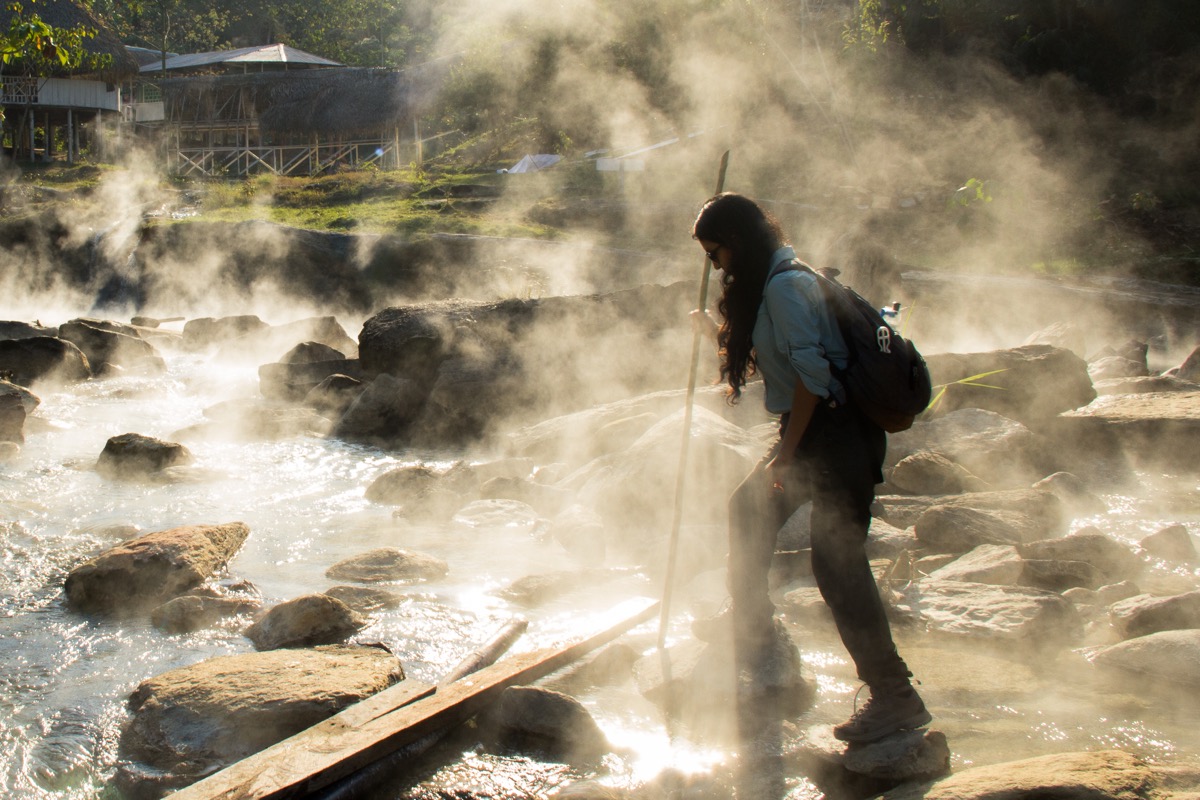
[772,260,934,433]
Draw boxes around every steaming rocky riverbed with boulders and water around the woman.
[0,277,1200,800]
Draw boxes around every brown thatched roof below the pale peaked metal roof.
[156,67,439,138]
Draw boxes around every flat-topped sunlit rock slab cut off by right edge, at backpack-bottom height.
[1055,391,1200,470]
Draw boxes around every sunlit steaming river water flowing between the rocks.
[0,321,1200,800]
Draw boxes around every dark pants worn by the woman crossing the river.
[728,404,910,685]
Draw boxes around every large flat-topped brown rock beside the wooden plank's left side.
[120,645,404,788]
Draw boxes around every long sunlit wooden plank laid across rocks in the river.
[170,602,659,800]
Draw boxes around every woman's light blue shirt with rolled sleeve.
[754,247,850,414]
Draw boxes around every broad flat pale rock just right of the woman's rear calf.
[893,578,1082,640]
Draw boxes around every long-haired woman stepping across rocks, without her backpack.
[692,193,932,742]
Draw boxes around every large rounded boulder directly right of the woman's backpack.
[925,344,1096,429]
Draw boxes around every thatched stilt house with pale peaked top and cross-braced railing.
[137,44,446,176]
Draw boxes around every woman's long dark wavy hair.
[691,192,786,402]
